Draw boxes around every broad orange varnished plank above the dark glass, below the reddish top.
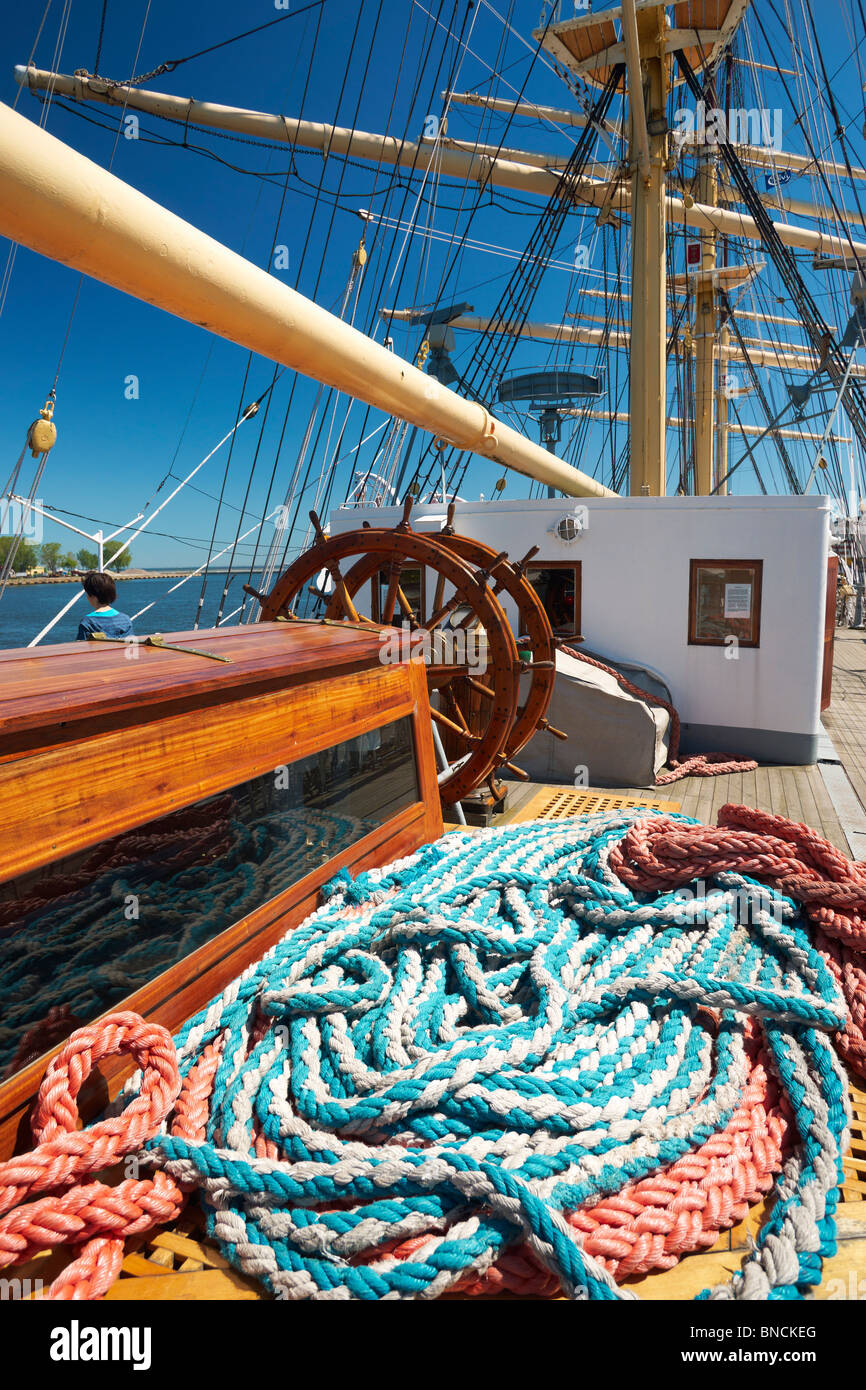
[0,662,435,883]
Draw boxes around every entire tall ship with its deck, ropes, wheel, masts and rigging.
[0,0,866,1323]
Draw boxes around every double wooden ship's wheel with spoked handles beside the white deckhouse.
[256,498,564,805]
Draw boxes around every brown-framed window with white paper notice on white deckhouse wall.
[688,560,763,646]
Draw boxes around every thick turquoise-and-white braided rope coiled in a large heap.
[125,812,848,1298]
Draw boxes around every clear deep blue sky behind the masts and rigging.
[0,0,866,566]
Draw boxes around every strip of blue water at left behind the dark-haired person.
[0,573,268,648]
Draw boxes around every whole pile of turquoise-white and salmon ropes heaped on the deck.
[0,809,866,1298]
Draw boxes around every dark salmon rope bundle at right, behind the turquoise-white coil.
[610,803,866,1077]
